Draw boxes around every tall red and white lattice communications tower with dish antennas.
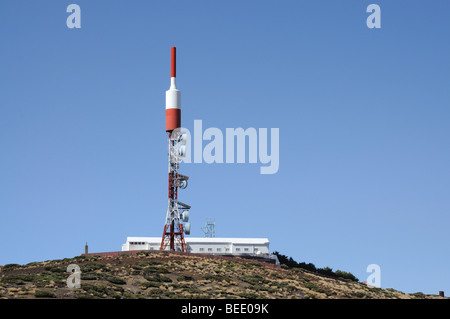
[160,47,191,252]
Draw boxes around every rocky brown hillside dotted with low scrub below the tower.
[0,252,440,299]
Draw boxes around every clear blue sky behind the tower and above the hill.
[0,0,450,294]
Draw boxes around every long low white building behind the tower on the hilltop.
[122,237,269,255]
